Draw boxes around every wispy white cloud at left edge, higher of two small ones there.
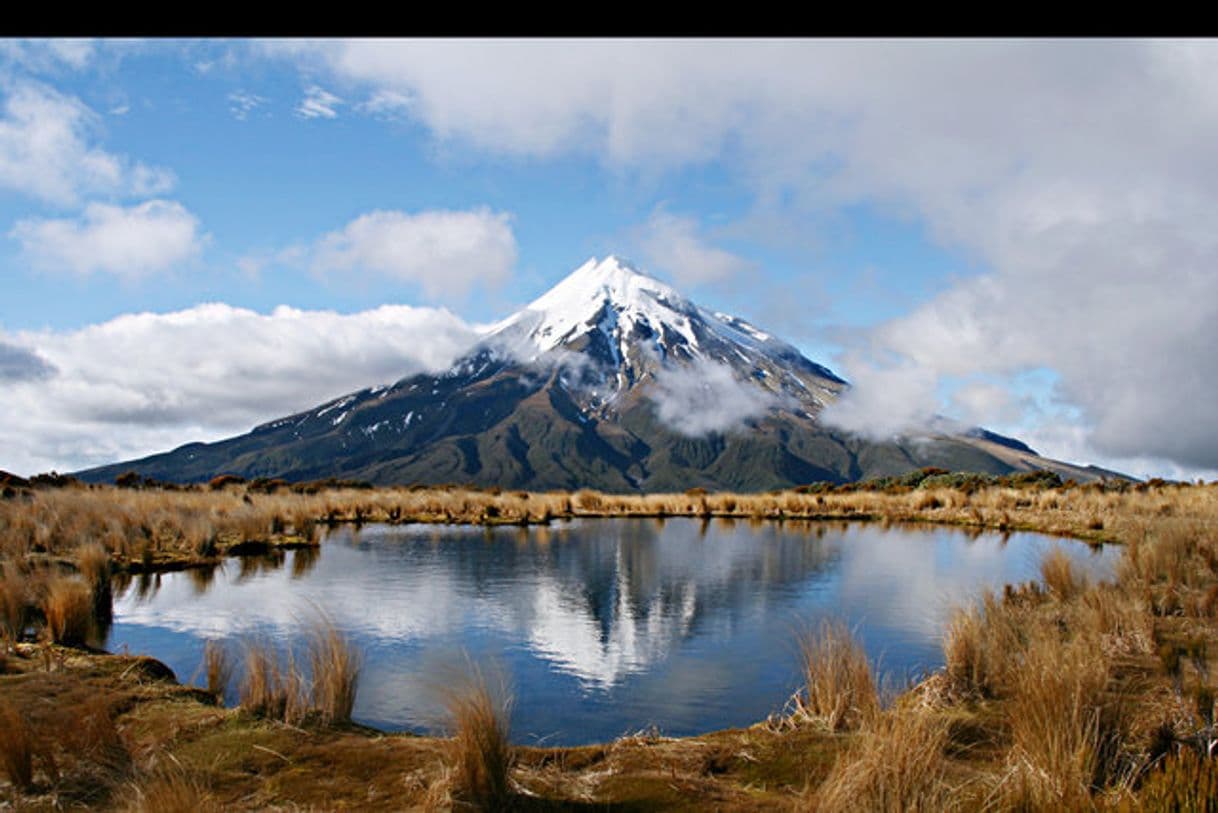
[0,82,173,205]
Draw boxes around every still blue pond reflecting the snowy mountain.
[107,519,1117,745]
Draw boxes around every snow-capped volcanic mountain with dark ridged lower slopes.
[79,256,1120,491]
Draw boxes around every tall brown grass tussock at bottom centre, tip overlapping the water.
[445,664,515,811]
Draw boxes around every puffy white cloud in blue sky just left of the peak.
[306,208,516,300]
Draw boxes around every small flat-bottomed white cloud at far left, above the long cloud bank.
[10,200,205,278]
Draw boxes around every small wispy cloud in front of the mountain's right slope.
[649,361,778,438]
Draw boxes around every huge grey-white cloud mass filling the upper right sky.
[261,40,1218,468]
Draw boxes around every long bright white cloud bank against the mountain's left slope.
[0,304,476,473]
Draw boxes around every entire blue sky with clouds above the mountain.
[0,39,1218,479]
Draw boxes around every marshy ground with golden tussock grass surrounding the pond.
[0,472,1218,811]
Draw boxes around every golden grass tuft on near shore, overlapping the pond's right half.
[797,619,879,731]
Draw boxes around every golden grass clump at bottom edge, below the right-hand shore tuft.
[812,709,965,813]
